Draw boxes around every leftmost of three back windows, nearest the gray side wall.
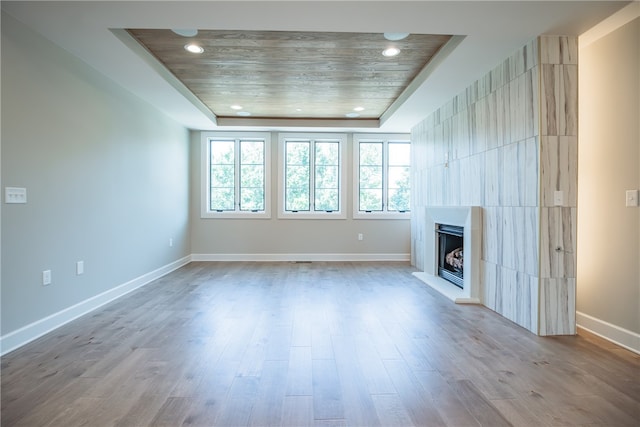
[202,132,271,218]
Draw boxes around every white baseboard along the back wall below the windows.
[191,254,411,262]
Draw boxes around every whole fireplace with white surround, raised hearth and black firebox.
[413,206,482,304]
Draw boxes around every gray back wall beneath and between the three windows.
[191,132,410,259]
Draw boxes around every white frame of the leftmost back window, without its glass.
[200,132,271,219]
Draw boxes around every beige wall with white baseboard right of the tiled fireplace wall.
[577,8,640,352]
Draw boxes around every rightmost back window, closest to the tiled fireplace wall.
[353,135,411,218]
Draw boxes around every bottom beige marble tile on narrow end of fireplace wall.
[538,278,576,336]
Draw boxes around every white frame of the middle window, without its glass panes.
[278,133,348,219]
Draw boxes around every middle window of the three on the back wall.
[278,134,346,219]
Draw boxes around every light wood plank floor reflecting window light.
[2,262,640,427]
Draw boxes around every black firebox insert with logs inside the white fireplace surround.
[436,224,464,289]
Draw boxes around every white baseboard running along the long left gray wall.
[0,255,191,355]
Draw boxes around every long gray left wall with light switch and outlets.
[1,14,190,336]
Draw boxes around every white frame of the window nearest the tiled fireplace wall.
[353,133,411,219]
